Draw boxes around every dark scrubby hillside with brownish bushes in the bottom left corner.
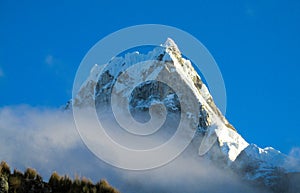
[0,161,119,193]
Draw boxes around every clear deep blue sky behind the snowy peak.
[0,0,300,153]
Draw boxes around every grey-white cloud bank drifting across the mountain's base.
[0,105,272,193]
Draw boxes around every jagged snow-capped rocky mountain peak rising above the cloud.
[72,38,300,192]
